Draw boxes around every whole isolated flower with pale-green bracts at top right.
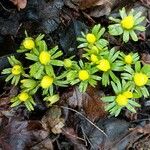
[108,8,145,42]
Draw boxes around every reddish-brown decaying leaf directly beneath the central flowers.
[61,87,106,121]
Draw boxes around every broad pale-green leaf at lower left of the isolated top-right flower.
[108,24,123,36]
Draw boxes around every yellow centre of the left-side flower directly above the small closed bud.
[41,75,54,89]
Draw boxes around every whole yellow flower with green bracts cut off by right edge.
[121,61,150,97]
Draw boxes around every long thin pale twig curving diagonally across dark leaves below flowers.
[61,106,108,137]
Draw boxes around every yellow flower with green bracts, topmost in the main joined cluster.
[77,24,108,50]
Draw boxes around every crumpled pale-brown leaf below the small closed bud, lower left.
[42,106,65,134]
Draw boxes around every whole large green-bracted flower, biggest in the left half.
[25,42,63,79]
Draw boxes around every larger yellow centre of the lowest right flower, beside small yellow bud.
[116,94,128,107]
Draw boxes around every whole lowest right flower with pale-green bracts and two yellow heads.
[102,80,140,117]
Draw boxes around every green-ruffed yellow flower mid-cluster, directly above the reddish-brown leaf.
[67,60,101,92]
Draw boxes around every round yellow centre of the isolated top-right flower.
[121,16,134,30]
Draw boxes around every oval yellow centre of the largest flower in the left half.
[39,51,51,65]
